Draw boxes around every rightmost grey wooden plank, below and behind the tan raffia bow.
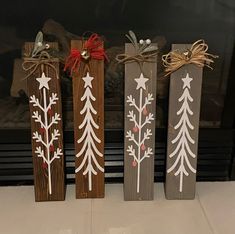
[165,44,202,199]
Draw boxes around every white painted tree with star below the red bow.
[75,72,104,191]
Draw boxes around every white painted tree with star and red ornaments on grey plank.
[126,73,154,193]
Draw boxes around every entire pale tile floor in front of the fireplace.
[0,182,235,234]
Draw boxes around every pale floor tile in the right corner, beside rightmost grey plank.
[197,182,235,234]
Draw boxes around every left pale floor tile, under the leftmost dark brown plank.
[0,185,91,234]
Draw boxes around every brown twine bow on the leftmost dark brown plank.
[22,51,59,80]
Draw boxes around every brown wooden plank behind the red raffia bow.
[71,40,104,198]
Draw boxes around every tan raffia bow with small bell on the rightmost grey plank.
[162,39,219,76]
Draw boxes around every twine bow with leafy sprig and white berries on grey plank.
[116,31,158,64]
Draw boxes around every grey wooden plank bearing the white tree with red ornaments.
[124,43,157,200]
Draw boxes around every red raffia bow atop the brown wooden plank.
[64,33,108,74]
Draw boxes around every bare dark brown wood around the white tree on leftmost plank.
[22,42,65,201]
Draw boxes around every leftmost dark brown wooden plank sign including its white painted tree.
[23,34,65,201]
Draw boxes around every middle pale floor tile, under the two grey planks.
[92,184,213,234]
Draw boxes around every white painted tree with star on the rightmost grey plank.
[167,73,196,192]
